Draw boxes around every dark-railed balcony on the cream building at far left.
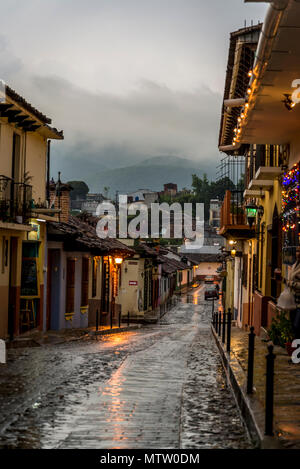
[0,175,32,225]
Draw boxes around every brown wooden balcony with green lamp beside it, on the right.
[220,191,255,239]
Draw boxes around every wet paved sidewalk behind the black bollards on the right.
[216,327,300,449]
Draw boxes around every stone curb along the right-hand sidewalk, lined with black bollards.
[211,327,282,449]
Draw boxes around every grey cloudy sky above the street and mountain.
[0,0,266,186]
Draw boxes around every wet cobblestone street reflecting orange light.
[0,289,252,449]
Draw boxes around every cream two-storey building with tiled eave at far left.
[0,86,63,339]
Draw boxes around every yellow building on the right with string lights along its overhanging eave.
[219,0,300,334]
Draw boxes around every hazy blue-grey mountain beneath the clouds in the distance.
[85,156,215,197]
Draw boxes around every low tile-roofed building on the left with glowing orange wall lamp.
[46,185,134,330]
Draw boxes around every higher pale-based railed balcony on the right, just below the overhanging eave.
[244,145,283,198]
